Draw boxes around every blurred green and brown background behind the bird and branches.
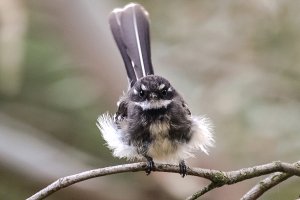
[0,0,300,200]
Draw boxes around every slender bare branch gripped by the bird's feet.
[27,161,300,200]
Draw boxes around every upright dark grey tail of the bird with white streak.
[109,3,154,86]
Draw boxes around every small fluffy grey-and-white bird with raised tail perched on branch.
[97,3,214,177]
